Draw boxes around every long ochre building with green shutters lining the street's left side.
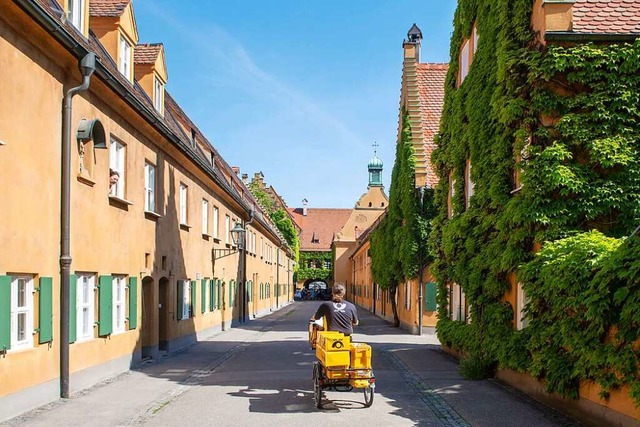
[0,0,293,421]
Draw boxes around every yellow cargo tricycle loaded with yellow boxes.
[309,321,376,409]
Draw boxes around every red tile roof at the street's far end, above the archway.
[288,208,353,251]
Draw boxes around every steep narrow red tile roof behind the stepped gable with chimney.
[416,64,449,188]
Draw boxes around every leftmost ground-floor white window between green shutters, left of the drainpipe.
[11,276,34,349]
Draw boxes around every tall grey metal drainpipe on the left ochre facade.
[60,52,96,398]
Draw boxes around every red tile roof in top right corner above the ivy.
[573,0,640,34]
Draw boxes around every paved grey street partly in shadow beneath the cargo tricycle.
[5,302,577,427]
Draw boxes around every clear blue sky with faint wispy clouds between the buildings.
[133,0,456,208]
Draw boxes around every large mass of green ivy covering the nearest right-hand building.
[430,0,640,405]
